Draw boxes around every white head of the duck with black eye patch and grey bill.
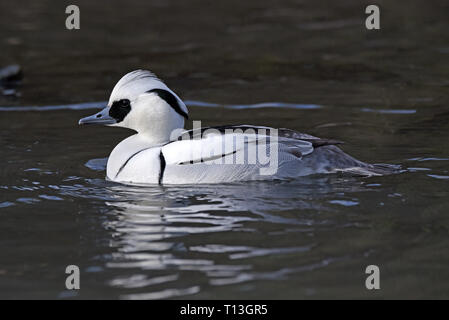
[79,70,188,143]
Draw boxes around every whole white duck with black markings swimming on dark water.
[80,70,396,184]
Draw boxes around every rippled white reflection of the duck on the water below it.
[73,177,366,298]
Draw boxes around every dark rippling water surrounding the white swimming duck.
[0,1,449,299]
